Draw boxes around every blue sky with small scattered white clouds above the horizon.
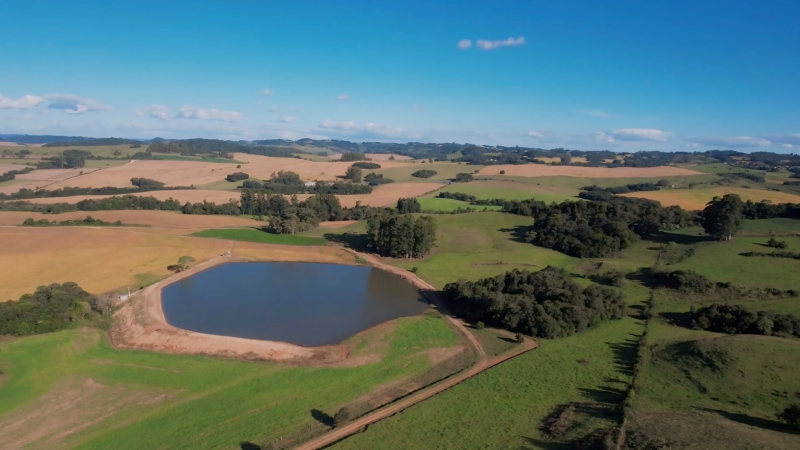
[0,0,800,152]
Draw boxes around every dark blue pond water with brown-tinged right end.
[162,262,428,346]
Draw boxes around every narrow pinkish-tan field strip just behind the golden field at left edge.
[0,210,266,234]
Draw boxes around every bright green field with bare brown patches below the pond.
[0,316,459,449]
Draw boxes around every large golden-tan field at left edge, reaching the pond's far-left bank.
[0,227,231,301]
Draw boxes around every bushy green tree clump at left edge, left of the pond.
[0,283,107,336]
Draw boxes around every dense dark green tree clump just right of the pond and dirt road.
[444,267,626,338]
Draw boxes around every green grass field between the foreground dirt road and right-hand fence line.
[333,319,642,449]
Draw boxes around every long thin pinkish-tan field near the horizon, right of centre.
[480,164,700,178]
